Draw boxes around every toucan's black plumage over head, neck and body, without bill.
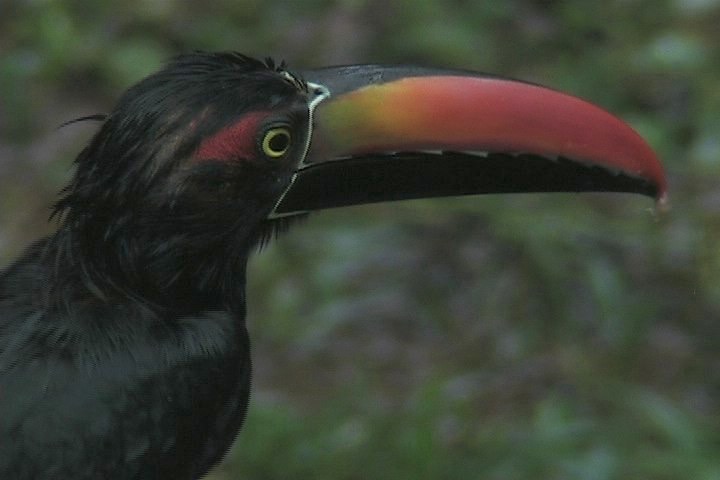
[0,53,309,479]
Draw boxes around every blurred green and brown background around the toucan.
[0,0,720,480]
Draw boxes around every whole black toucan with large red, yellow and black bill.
[0,51,667,479]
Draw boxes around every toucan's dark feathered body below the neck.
[0,240,250,479]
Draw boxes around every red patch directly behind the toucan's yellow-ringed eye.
[195,112,270,161]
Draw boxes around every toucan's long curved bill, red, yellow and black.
[275,66,667,215]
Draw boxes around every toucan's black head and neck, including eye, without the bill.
[55,53,326,308]
